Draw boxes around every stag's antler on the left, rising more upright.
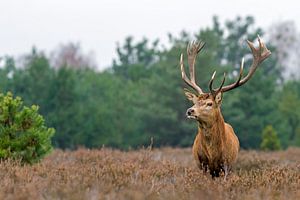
[180,42,205,94]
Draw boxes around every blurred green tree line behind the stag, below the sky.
[0,16,300,149]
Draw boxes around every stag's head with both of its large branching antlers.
[180,36,271,124]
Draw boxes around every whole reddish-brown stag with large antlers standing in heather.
[180,36,271,179]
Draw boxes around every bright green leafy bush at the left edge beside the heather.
[0,92,55,164]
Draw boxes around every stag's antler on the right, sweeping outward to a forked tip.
[209,35,271,95]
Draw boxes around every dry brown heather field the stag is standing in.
[0,148,300,200]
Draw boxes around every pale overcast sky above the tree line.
[0,0,300,68]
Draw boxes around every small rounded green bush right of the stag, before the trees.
[260,125,281,150]
